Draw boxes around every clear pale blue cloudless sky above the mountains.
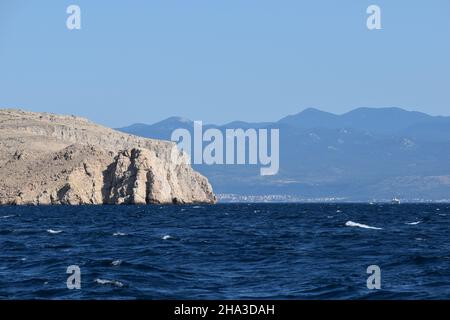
[0,0,450,127]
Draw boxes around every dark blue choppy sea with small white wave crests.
[0,204,450,299]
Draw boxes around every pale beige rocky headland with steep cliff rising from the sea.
[0,109,216,205]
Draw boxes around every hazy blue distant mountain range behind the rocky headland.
[118,108,450,201]
